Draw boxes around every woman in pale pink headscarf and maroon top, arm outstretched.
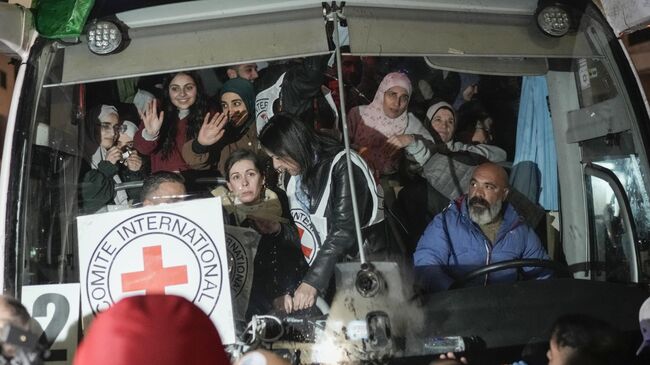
[348,72,433,176]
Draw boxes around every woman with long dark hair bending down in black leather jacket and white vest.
[259,113,383,310]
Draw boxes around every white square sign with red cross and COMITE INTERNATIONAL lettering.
[77,198,235,344]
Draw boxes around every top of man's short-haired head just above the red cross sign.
[141,171,186,206]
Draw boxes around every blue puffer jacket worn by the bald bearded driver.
[413,196,550,291]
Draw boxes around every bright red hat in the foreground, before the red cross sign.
[73,295,230,365]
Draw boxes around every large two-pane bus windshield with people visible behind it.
[15,1,650,363]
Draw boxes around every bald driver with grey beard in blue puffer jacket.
[413,163,550,292]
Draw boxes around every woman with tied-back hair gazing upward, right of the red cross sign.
[213,149,307,318]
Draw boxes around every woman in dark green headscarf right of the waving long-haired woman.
[183,78,264,173]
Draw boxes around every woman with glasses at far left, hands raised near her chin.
[81,105,143,213]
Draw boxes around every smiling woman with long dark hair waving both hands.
[133,71,226,172]
